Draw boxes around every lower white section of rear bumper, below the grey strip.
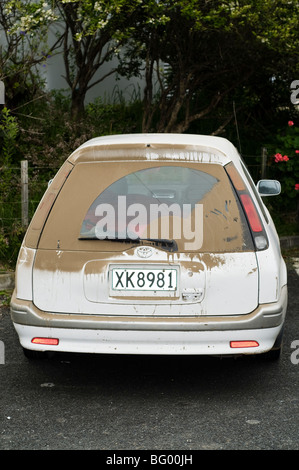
[15,324,281,355]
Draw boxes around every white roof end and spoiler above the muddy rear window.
[68,133,244,166]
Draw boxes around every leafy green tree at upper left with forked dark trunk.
[7,0,142,117]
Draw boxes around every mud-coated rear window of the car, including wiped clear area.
[40,162,253,253]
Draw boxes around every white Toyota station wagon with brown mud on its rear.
[11,134,287,357]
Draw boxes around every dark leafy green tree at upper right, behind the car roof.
[126,0,298,134]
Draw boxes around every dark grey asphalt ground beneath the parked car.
[0,264,299,452]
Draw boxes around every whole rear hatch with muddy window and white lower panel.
[33,161,258,317]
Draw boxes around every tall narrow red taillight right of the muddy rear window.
[229,163,268,250]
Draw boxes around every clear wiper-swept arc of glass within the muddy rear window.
[80,166,218,239]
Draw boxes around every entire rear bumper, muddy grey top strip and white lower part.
[11,286,287,355]
